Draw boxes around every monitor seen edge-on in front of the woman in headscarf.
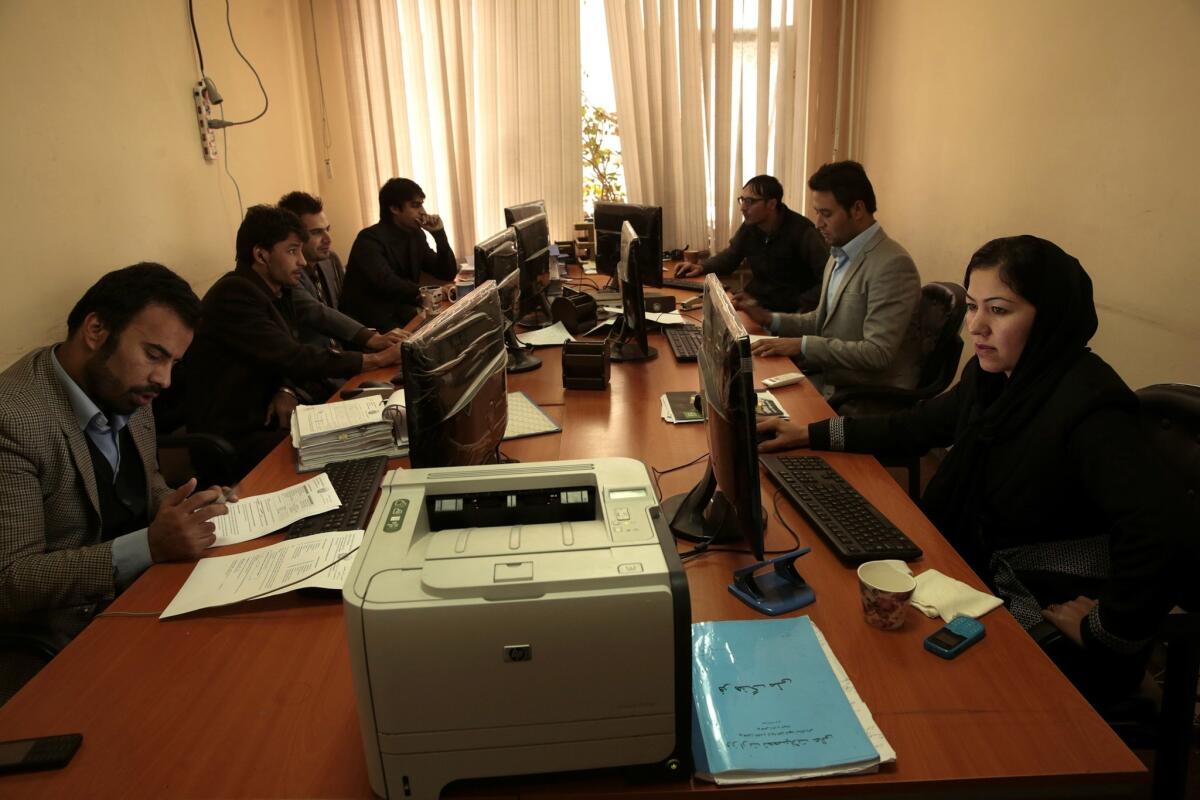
[662,275,766,561]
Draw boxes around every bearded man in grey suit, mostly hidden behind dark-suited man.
[280,192,408,351]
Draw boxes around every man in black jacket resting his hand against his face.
[342,178,457,331]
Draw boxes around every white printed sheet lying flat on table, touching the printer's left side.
[158,530,362,619]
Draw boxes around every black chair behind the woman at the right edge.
[1132,384,1200,800]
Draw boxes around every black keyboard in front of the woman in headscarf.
[758,456,922,564]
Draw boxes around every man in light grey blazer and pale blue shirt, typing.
[734,161,920,398]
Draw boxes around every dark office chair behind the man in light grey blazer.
[829,282,967,501]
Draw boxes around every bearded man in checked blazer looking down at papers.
[0,264,226,703]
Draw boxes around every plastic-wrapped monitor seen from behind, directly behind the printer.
[401,281,509,468]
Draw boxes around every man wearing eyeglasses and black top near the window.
[676,175,829,312]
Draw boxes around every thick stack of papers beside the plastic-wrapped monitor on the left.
[292,392,408,473]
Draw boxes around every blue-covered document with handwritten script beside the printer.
[691,616,896,784]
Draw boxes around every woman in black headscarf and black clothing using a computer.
[760,236,1195,705]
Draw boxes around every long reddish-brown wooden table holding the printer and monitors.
[0,273,1146,799]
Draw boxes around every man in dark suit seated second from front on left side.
[184,205,400,476]
